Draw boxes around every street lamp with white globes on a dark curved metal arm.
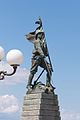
[0,46,23,80]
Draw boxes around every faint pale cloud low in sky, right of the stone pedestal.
[61,110,80,120]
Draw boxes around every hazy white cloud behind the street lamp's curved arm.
[0,62,29,84]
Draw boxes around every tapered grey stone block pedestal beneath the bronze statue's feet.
[21,85,61,120]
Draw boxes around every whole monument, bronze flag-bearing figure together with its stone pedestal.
[21,17,61,120]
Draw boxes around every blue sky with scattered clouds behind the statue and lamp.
[0,0,80,120]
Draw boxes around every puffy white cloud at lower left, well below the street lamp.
[0,95,19,113]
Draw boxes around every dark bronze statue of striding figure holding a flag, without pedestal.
[26,18,54,90]
